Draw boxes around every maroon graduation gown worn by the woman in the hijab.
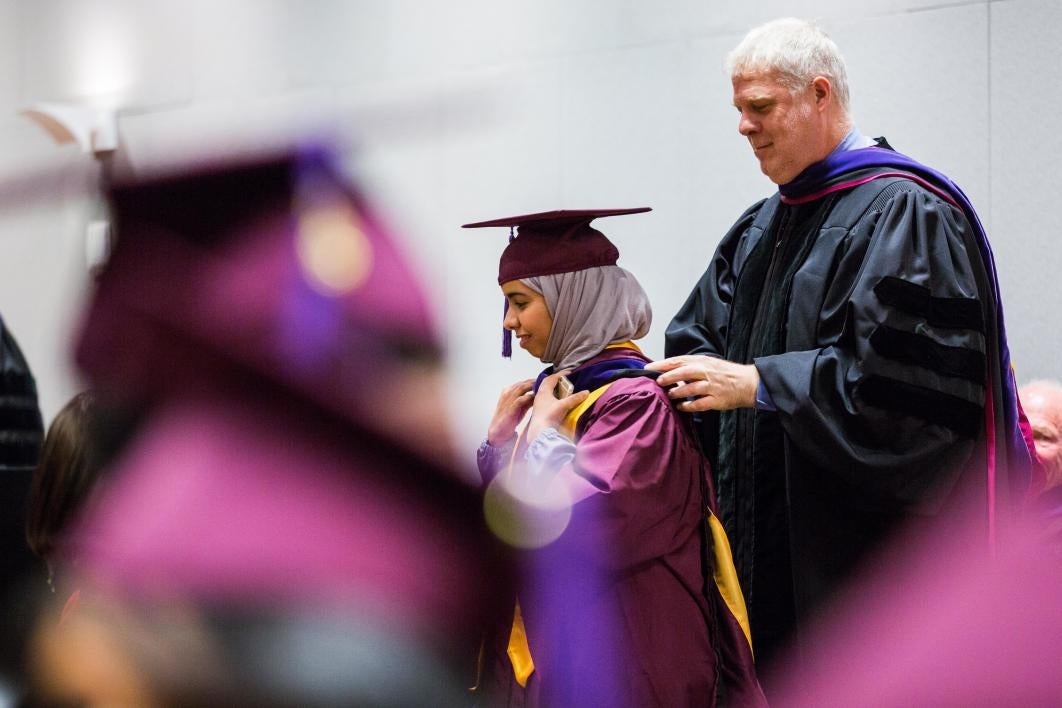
[481,349,717,706]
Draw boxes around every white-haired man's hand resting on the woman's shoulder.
[646,355,759,413]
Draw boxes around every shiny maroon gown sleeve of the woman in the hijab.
[543,379,706,570]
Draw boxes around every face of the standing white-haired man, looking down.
[733,71,833,185]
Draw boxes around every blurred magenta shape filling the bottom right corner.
[773,501,1062,707]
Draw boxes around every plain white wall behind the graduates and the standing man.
[0,0,1062,454]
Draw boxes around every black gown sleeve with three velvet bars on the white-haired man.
[755,188,987,511]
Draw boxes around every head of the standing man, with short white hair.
[726,18,852,185]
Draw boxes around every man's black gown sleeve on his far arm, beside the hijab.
[664,202,764,357]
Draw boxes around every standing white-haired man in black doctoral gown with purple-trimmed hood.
[649,19,1030,688]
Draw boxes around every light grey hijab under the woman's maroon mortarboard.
[520,265,653,369]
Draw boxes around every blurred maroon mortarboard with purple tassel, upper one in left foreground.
[76,148,440,439]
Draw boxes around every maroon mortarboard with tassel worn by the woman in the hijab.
[462,207,652,357]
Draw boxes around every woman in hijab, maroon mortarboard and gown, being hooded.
[466,208,761,706]
